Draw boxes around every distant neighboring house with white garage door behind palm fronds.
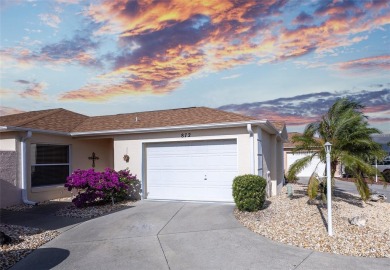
[284,132,325,177]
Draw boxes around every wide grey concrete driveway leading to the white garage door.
[11,201,390,270]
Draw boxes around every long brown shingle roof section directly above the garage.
[73,107,255,132]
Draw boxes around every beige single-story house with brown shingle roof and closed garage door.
[0,107,287,207]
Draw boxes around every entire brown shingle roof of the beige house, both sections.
[0,107,256,132]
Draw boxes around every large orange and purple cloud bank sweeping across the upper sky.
[58,0,390,101]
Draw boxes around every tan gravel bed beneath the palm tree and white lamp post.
[234,184,390,258]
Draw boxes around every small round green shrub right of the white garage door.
[233,174,267,212]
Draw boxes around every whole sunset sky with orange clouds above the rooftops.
[0,0,390,133]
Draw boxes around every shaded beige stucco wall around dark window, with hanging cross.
[20,133,113,202]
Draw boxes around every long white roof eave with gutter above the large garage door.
[70,120,272,137]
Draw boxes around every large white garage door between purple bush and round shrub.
[146,140,238,202]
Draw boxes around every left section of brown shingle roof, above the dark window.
[0,109,88,132]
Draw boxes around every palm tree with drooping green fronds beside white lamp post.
[287,98,385,201]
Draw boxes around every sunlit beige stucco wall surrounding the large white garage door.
[114,127,283,198]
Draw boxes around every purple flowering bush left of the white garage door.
[65,168,139,207]
